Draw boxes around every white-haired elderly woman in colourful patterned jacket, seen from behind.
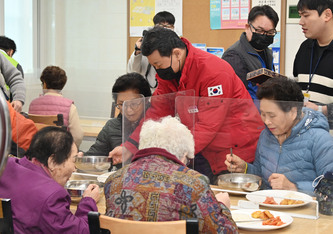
[105,116,237,233]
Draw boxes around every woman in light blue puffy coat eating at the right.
[225,78,333,194]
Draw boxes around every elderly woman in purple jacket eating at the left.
[0,127,100,233]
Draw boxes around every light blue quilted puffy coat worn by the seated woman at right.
[248,108,333,194]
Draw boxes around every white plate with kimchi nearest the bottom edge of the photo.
[231,209,293,231]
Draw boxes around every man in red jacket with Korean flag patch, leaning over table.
[109,27,263,183]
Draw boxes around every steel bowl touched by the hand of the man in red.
[75,156,111,174]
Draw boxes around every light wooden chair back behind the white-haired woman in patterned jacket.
[88,211,199,234]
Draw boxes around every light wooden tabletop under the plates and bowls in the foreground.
[70,185,333,234]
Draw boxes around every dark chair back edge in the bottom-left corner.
[0,198,14,234]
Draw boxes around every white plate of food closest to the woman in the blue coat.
[246,190,313,208]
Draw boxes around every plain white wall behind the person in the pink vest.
[24,0,127,117]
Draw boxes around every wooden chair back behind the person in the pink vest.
[28,114,64,130]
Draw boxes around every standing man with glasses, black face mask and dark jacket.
[222,5,279,99]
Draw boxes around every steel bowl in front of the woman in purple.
[65,180,104,197]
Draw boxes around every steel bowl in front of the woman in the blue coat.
[217,173,261,191]
